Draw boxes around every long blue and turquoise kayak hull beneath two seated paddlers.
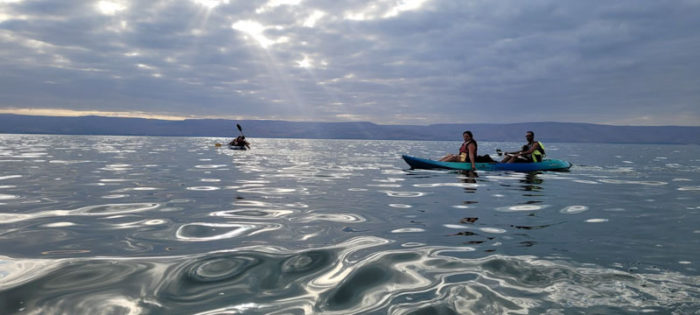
[402,155,571,172]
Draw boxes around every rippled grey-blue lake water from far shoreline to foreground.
[0,135,700,314]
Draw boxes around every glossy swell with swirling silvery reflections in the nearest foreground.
[1,242,700,314]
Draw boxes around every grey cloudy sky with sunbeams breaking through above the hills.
[0,0,700,126]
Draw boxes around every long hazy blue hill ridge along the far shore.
[0,114,700,144]
